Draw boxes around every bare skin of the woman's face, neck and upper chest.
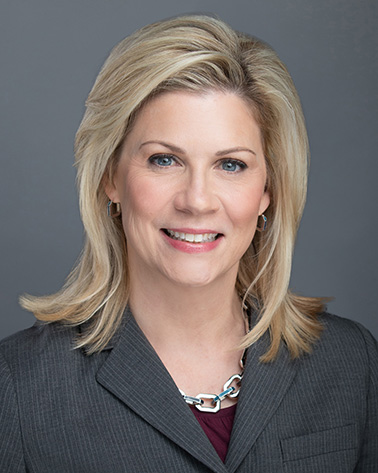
[105,91,269,405]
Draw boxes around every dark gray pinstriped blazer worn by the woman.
[0,312,378,473]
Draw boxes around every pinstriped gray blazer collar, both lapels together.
[97,309,297,473]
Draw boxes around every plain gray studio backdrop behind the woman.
[0,0,378,338]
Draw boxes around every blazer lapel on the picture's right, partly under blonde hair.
[225,334,297,472]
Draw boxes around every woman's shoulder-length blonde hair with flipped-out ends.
[21,16,323,361]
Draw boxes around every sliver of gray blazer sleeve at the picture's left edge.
[0,353,26,473]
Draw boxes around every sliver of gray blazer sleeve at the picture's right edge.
[354,324,378,473]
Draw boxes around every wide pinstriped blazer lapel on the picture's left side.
[97,311,227,473]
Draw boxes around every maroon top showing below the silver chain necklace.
[190,404,237,463]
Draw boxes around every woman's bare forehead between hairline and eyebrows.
[125,91,260,152]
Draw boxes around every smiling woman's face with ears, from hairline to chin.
[106,92,269,287]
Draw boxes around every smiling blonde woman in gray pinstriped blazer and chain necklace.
[0,16,378,473]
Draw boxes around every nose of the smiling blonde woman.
[174,170,220,215]
